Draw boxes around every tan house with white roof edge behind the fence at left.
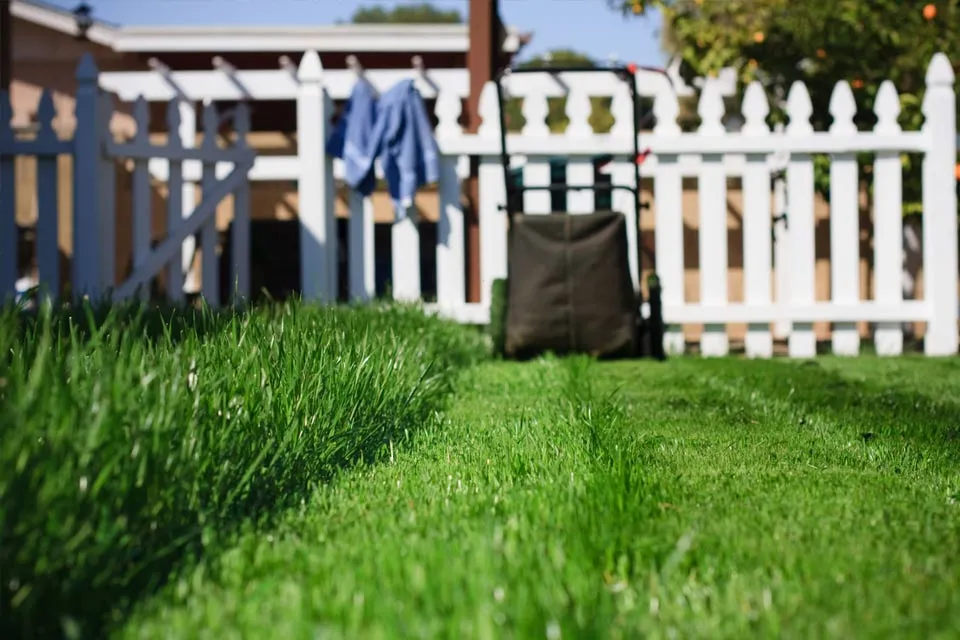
[11,0,530,298]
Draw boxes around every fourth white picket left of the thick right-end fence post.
[742,82,773,358]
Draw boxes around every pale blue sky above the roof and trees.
[39,0,663,64]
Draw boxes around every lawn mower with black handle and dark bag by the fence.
[490,64,665,360]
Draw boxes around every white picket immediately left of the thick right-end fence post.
[873,80,905,356]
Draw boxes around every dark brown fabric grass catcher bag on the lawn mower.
[504,211,639,359]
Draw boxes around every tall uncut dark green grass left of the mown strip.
[0,305,484,638]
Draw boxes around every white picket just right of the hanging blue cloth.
[434,91,467,310]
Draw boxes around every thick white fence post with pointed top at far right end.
[923,53,958,356]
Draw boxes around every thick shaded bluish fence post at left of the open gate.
[73,53,106,300]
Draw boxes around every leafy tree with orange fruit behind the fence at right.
[608,0,960,213]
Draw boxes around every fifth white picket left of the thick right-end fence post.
[697,79,728,356]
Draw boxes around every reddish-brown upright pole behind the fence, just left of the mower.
[466,0,500,302]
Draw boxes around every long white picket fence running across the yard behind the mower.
[0,52,958,357]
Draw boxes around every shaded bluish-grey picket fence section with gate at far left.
[0,56,254,304]
